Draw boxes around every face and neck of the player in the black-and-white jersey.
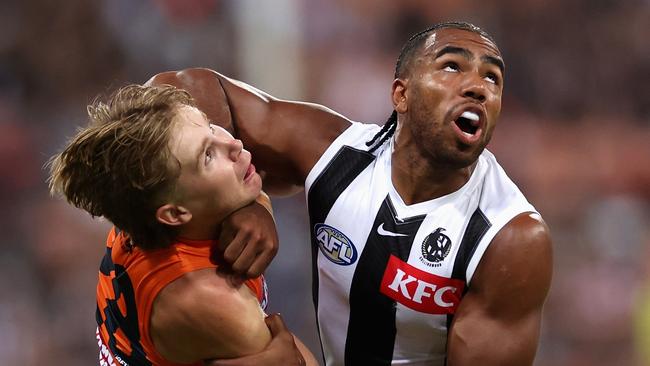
[392,30,503,204]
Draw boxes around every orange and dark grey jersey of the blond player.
[96,228,267,366]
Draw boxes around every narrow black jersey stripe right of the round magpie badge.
[447,208,492,329]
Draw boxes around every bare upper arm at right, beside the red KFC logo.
[447,213,552,366]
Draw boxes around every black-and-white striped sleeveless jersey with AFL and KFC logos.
[305,122,536,366]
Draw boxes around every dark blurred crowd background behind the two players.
[0,0,650,366]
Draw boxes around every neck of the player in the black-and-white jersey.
[391,127,476,205]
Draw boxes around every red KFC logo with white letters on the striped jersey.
[381,255,465,314]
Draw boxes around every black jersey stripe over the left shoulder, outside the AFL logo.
[307,146,375,362]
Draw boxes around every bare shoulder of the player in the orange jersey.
[150,269,270,363]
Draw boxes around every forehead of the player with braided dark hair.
[422,28,501,57]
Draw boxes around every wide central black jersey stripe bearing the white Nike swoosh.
[345,196,426,365]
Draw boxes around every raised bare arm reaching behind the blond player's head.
[147,68,350,194]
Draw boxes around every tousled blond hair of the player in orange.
[48,85,194,249]
